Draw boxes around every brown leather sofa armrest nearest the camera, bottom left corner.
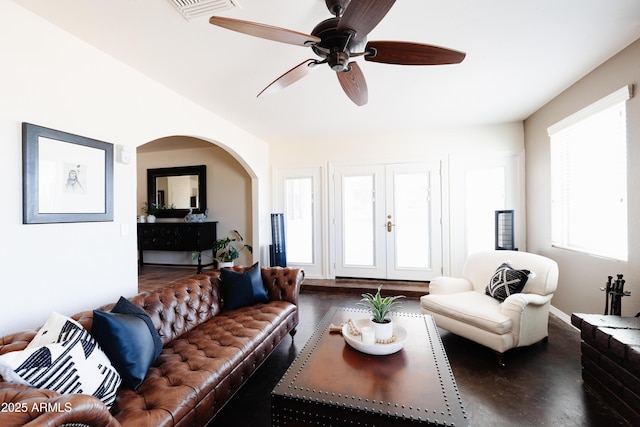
[0,382,120,427]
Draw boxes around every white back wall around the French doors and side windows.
[269,123,526,280]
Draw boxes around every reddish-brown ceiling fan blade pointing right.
[364,41,466,65]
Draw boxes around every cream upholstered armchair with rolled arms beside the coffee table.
[420,250,558,366]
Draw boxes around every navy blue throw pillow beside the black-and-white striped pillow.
[91,297,162,390]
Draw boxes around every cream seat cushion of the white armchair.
[420,291,512,335]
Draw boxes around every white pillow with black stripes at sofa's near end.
[0,313,122,407]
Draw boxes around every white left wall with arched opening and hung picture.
[0,1,270,335]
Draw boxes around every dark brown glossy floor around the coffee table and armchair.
[139,266,629,427]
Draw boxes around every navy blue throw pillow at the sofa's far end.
[220,263,269,310]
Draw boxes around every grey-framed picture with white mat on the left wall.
[22,123,113,224]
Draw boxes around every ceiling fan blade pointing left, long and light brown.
[209,16,320,46]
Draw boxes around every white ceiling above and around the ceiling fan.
[14,0,640,142]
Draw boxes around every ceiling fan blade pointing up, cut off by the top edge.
[338,0,396,40]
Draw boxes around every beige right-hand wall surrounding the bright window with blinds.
[525,40,640,316]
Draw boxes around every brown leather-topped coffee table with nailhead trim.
[271,307,469,427]
